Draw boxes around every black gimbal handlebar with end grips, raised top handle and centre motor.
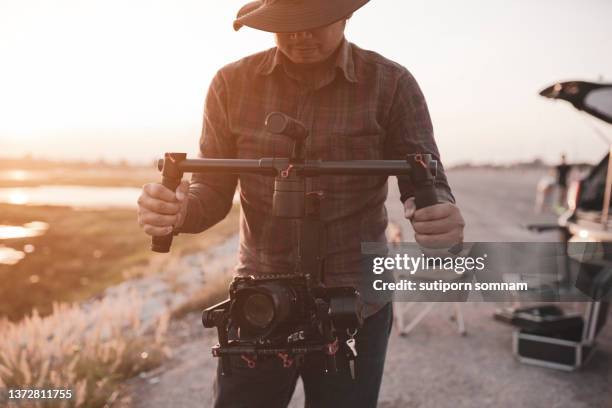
[151,112,438,252]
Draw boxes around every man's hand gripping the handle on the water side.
[138,181,189,236]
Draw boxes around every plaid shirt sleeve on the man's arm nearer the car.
[385,70,455,207]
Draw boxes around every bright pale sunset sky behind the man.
[0,0,612,163]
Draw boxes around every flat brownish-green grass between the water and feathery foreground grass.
[0,204,239,320]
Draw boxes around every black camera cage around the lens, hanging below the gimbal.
[202,274,362,373]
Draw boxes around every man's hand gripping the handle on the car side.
[404,198,465,248]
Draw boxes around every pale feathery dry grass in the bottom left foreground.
[0,292,170,407]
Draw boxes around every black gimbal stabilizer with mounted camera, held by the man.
[151,112,437,373]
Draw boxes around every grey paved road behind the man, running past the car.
[126,170,612,408]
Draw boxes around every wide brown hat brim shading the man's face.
[234,0,369,33]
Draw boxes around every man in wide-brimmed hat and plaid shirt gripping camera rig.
[139,0,464,408]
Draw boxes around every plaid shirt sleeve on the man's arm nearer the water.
[180,71,238,233]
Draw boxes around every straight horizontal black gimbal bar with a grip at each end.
[151,153,438,252]
